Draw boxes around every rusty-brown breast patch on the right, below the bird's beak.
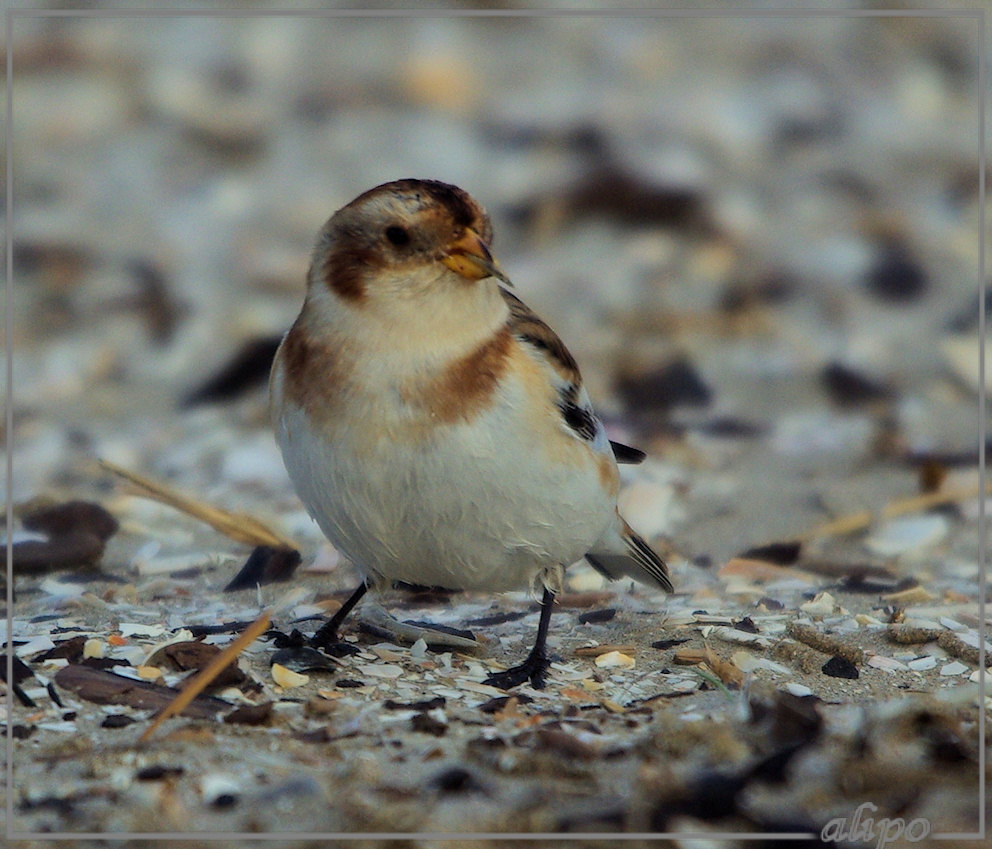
[420,327,513,423]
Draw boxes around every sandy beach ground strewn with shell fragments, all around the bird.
[4,3,989,847]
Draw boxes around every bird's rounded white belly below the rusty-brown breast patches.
[272,358,615,591]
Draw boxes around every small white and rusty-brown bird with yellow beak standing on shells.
[269,179,673,690]
